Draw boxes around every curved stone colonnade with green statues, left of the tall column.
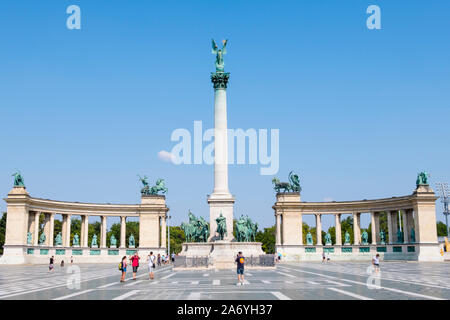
[0,186,169,263]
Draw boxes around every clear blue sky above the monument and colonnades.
[0,0,450,227]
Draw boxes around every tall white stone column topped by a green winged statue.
[208,40,234,241]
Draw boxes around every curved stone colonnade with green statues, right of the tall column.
[272,185,441,261]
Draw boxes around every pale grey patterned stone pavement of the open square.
[0,262,450,300]
